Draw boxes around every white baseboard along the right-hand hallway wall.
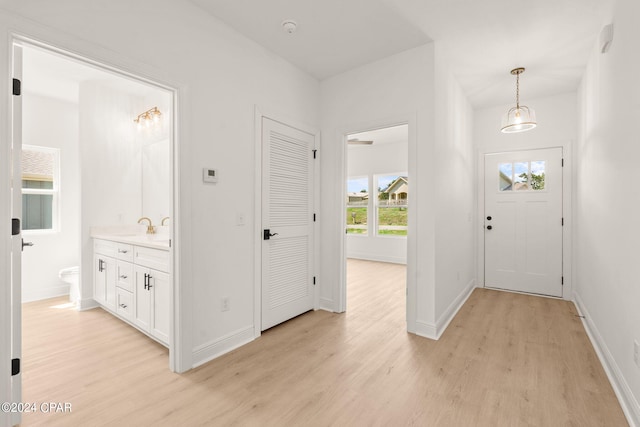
[573,292,640,427]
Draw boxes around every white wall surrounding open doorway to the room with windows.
[319,44,434,330]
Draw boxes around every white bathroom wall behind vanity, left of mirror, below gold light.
[78,81,142,308]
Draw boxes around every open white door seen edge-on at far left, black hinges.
[11,41,23,425]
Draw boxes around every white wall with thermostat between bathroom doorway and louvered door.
[0,0,319,369]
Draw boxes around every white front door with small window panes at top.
[484,148,563,297]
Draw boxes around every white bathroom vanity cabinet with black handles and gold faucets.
[93,236,171,346]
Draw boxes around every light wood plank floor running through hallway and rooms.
[23,261,627,426]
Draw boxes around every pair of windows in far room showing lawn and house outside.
[346,174,409,236]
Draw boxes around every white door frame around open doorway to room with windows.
[336,115,419,333]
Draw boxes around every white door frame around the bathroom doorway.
[8,33,186,372]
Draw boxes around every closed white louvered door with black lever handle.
[260,118,315,330]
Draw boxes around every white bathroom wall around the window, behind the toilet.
[22,92,80,302]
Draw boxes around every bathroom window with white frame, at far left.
[22,145,60,231]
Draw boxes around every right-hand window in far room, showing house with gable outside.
[377,175,409,236]
